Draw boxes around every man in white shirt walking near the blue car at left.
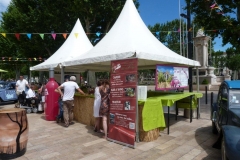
[15,75,30,107]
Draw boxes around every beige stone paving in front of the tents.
[0,91,221,160]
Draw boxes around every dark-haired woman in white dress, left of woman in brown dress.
[93,81,102,132]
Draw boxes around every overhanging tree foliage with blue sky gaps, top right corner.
[186,0,240,51]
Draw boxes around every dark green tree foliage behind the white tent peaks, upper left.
[0,0,139,77]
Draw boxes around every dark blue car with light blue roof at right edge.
[211,80,240,160]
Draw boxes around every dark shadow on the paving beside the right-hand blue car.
[195,126,221,160]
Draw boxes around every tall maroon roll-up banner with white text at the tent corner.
[108,58,138,147]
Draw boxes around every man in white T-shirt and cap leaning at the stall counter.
[58,76,85,127]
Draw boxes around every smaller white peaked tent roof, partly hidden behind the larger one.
[30,19,93,70]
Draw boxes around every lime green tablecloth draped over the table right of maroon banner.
[138,92,202,131]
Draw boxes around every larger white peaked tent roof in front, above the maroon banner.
[63,0,200,70]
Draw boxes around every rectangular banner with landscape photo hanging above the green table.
[155,65,189,90]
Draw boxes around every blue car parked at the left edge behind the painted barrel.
[0,81,18,103]
